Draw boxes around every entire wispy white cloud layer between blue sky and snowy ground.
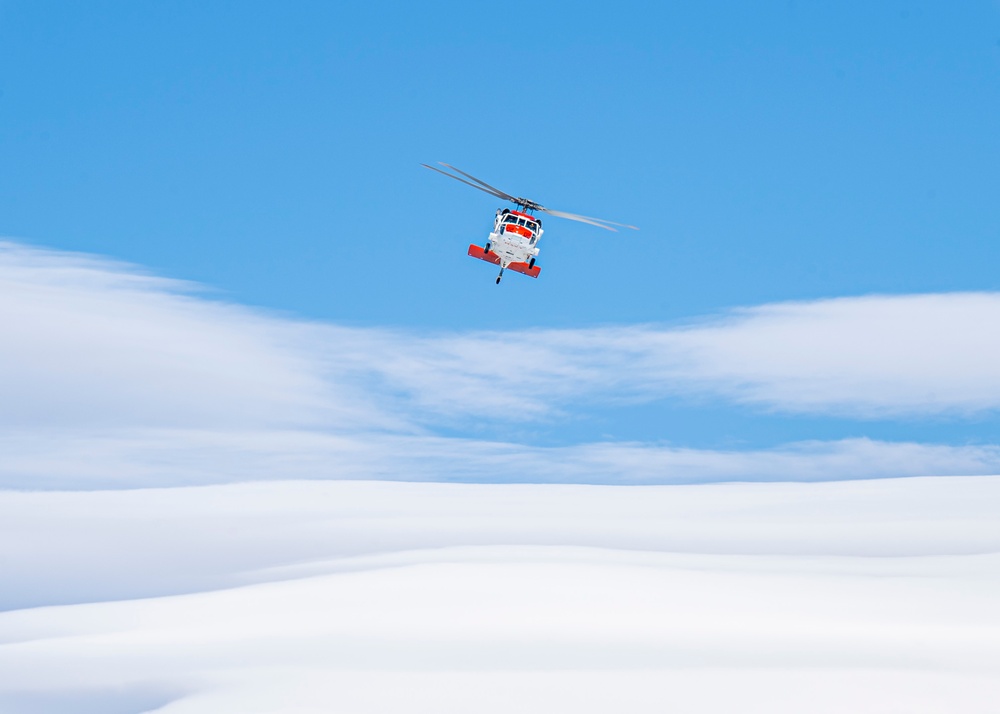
[0,243,1000,488]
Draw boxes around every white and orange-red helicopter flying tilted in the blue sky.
[421,161,639,285]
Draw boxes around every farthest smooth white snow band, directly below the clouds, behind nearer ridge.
[0,477,1000,609]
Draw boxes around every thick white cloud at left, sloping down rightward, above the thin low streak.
[0,244,392,429]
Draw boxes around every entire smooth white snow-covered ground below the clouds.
[0,477,1000,714]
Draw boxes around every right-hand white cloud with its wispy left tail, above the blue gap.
[362,293,1000,418]
